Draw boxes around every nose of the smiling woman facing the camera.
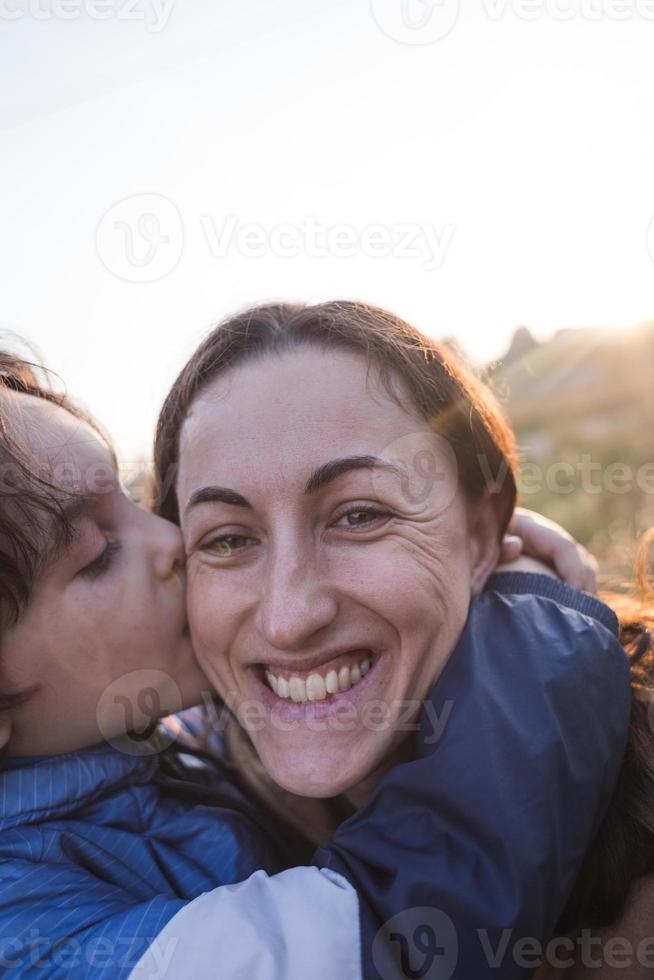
[257,556,337,651]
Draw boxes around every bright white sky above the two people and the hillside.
[0,0,654,459]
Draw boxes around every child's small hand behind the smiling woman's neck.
[497,507,597,593]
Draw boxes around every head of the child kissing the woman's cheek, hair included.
[0,354,206,755]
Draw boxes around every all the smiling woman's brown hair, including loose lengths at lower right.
[155,302,654,931]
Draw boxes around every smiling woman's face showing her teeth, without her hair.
[177,348,497,797]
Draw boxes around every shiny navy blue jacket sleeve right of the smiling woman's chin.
[316,573,630,980]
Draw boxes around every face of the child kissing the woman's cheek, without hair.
[0,392,207,755]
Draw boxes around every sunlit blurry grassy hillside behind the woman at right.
[486,323,654,576]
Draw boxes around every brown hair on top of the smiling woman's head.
[154,301,517,534]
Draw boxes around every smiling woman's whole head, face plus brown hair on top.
[157,303,516,802]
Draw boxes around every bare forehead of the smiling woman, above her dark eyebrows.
[178,350,452,509]
